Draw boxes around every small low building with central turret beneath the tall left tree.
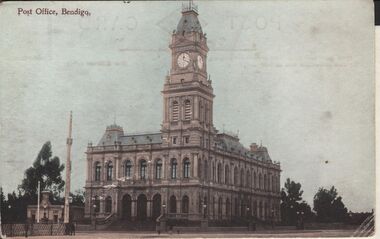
[27,191,84,223]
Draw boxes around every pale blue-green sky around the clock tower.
[0,0,375,211]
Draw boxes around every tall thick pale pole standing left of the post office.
[63,111,73,223]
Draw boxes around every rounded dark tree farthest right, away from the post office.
[314,186,348,222]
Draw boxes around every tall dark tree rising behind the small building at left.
[19,141,65,198]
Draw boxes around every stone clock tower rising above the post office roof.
[161,1,215,147]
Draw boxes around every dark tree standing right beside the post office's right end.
[281,178,313,225]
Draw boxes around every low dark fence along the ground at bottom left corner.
[1,223,69,237]
